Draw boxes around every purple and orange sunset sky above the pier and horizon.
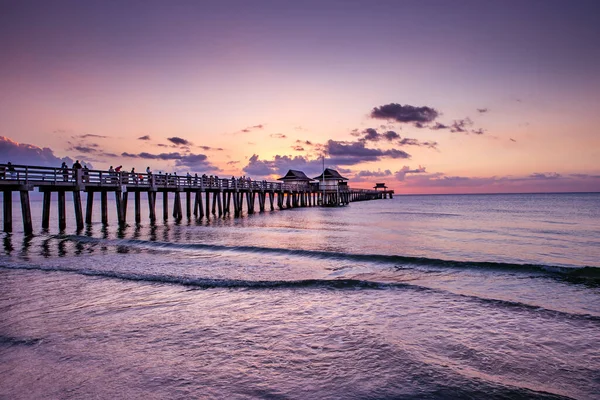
[0,0,600,194]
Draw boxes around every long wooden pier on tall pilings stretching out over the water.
[0,164,394,235]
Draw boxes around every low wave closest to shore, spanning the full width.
[0,265,600,322]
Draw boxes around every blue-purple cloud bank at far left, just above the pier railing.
[0,136,91,168]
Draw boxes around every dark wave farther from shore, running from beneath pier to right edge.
[57,235,600,285]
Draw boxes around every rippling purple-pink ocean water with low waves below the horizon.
[0,193,600,399]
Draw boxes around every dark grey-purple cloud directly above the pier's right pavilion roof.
[325,140,410,165]
